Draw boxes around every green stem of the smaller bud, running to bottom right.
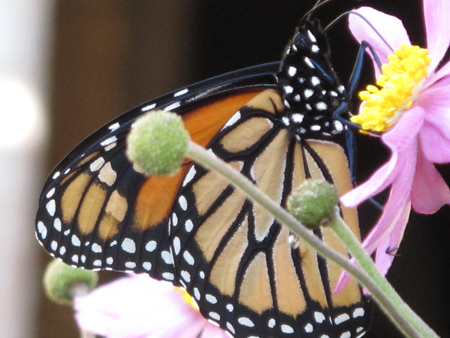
[328,207,438,338]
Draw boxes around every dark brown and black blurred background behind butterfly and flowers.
[37,0,450,338]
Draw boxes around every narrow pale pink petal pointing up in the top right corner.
[423,0,450,71]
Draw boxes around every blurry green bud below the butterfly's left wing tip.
[43,259,98,305]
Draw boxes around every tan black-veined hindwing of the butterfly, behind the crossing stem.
[170,90,370,337]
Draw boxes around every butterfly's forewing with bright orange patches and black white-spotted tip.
[36,63,279,283]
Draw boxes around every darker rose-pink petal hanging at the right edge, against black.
[411,148,450,214]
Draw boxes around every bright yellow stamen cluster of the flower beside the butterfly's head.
[350,44,431,132]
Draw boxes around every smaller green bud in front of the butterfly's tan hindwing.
[287,180,339,229]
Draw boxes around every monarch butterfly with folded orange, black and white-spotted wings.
[36,1,370,338]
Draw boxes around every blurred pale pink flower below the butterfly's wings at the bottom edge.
[74,275,228,338]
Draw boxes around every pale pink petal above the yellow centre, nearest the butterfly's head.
[349,7,410,75]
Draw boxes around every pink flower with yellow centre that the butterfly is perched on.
[340,0,450,287]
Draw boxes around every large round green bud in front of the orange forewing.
[127,110,190,176]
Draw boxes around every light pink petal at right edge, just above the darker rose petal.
[420,122,450,164]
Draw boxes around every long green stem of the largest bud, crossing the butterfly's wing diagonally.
[187,142,437,338]
